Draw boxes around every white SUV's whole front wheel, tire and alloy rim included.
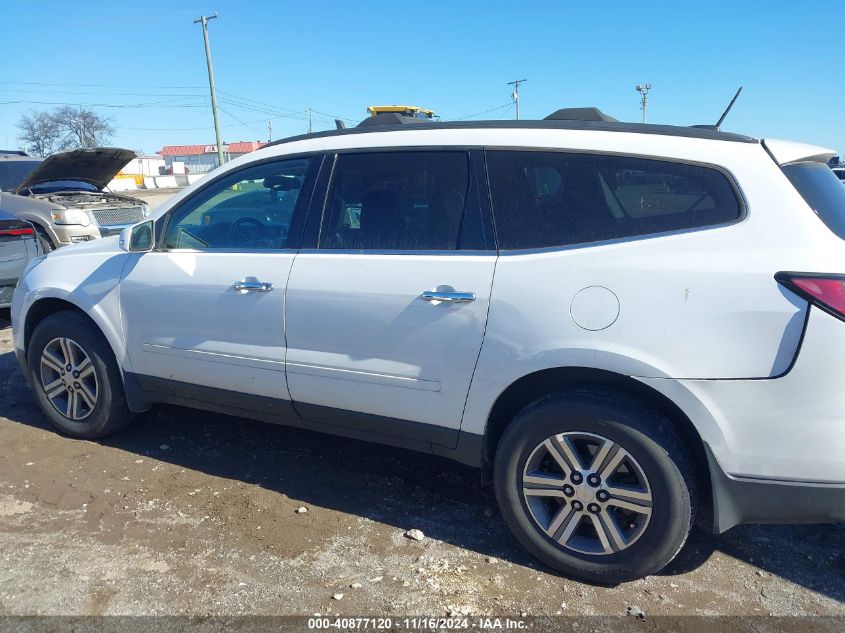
[27,311,132,439]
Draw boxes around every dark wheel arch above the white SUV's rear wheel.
[481,367,713,529]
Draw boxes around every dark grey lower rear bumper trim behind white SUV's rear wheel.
[707,447,845,533]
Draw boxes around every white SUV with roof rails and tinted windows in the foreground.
[12,110,845,583]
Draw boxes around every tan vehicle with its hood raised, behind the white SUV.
[0,147,149,252]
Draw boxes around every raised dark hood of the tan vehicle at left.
[15,147,137,192]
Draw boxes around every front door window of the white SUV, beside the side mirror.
[164,158,313,250]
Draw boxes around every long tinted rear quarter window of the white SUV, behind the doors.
[487,150,741,249]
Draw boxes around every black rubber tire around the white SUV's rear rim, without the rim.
[493,388,695,585]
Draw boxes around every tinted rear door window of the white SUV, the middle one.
[319,152,477,250]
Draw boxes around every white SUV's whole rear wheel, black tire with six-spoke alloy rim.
[494,389,694,584]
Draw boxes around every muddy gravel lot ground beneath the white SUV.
[0,311,845,616]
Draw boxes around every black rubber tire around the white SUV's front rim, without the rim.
[27,311,134,439]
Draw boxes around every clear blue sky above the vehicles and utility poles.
[0,0,845,152]
